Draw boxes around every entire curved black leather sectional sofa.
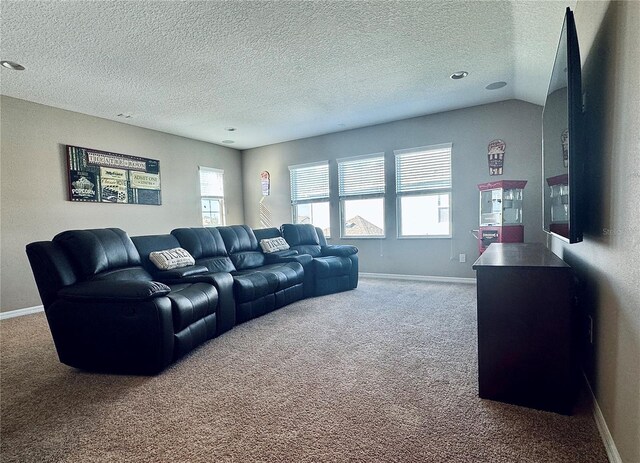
[26,224,358,374]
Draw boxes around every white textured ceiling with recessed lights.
[0,0,575,149]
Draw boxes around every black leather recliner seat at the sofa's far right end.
[280,223,358,296]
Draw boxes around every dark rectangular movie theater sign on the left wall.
[67,145,162,205]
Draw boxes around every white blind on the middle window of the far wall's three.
[338,153,385,198]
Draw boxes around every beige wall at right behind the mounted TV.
[549,1,640,463]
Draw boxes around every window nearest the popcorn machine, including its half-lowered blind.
[394,143,451,237]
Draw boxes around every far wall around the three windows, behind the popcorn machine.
[242,100,545,278]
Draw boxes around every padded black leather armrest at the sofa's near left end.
[58,280,171,302]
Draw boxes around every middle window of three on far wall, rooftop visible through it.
[338,153,385,238]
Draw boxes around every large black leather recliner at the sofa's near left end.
[26,228,218,374]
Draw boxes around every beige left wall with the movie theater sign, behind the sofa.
[0,97,244,311]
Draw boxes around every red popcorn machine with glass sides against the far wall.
[478,180,527,254]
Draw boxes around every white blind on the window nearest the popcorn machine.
[394,143,451,193]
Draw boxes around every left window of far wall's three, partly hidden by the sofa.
[289,161,331,238]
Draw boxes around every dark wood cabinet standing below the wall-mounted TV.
[473,243,577,414]
